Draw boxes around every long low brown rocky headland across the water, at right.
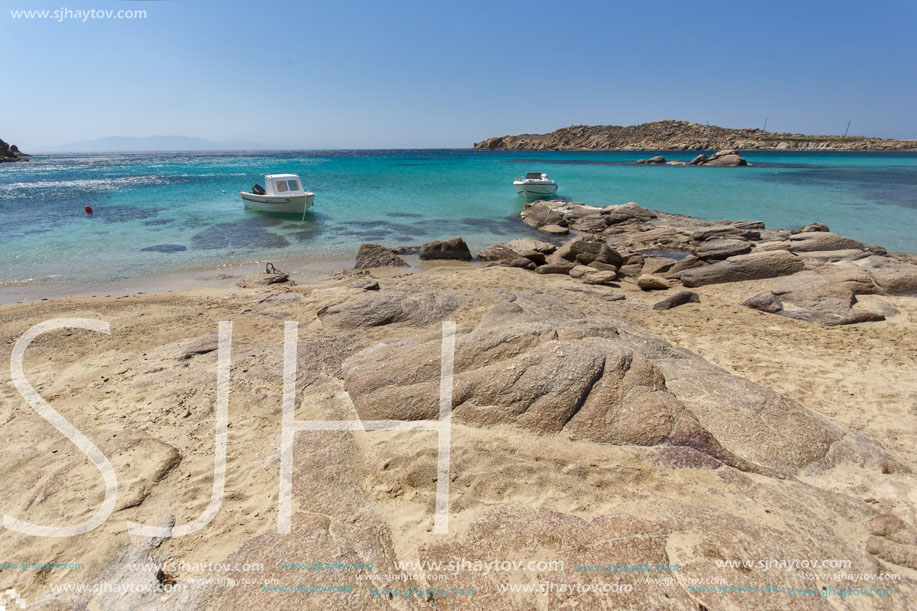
[474,121,917,151]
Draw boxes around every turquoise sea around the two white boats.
[0,150,917,283]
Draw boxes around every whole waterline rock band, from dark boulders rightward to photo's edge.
[346,200,917,325]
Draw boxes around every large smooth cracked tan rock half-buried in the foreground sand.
[342,293,844,475]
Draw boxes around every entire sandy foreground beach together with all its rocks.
[0,201,917,610]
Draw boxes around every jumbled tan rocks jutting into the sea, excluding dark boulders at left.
[522,202,917,325]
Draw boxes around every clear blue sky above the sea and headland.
[0,0,917,150]
